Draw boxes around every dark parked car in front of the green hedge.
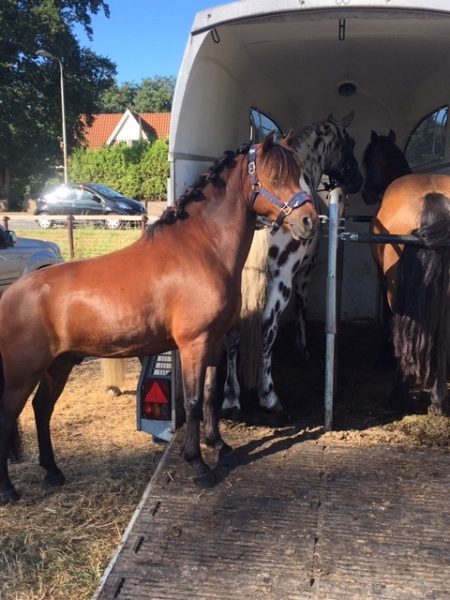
[34,183,146,229]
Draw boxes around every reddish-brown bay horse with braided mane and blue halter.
[0,136,318,503]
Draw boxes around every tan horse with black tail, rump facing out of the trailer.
[362,130,450,415]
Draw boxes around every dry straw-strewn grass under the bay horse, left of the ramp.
[0,360,163,600]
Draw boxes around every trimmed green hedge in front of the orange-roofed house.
[70,140,169,200]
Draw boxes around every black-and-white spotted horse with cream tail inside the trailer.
[222,112,363,411]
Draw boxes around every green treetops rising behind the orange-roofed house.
[100,76,175,113]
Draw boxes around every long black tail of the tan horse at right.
[392,193,450,389]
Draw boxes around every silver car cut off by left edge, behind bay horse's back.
[0,225,64,295]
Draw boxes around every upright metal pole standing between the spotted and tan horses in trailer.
[325,188,342,431]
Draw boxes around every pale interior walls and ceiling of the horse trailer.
[170,0,450,318]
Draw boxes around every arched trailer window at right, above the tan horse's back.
[405,106,448,168]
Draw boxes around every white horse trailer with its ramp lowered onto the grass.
[95,0,450,600]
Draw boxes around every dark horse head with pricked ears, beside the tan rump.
[361,129,411,204]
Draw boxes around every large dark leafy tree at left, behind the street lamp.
[0,0,115,208]
